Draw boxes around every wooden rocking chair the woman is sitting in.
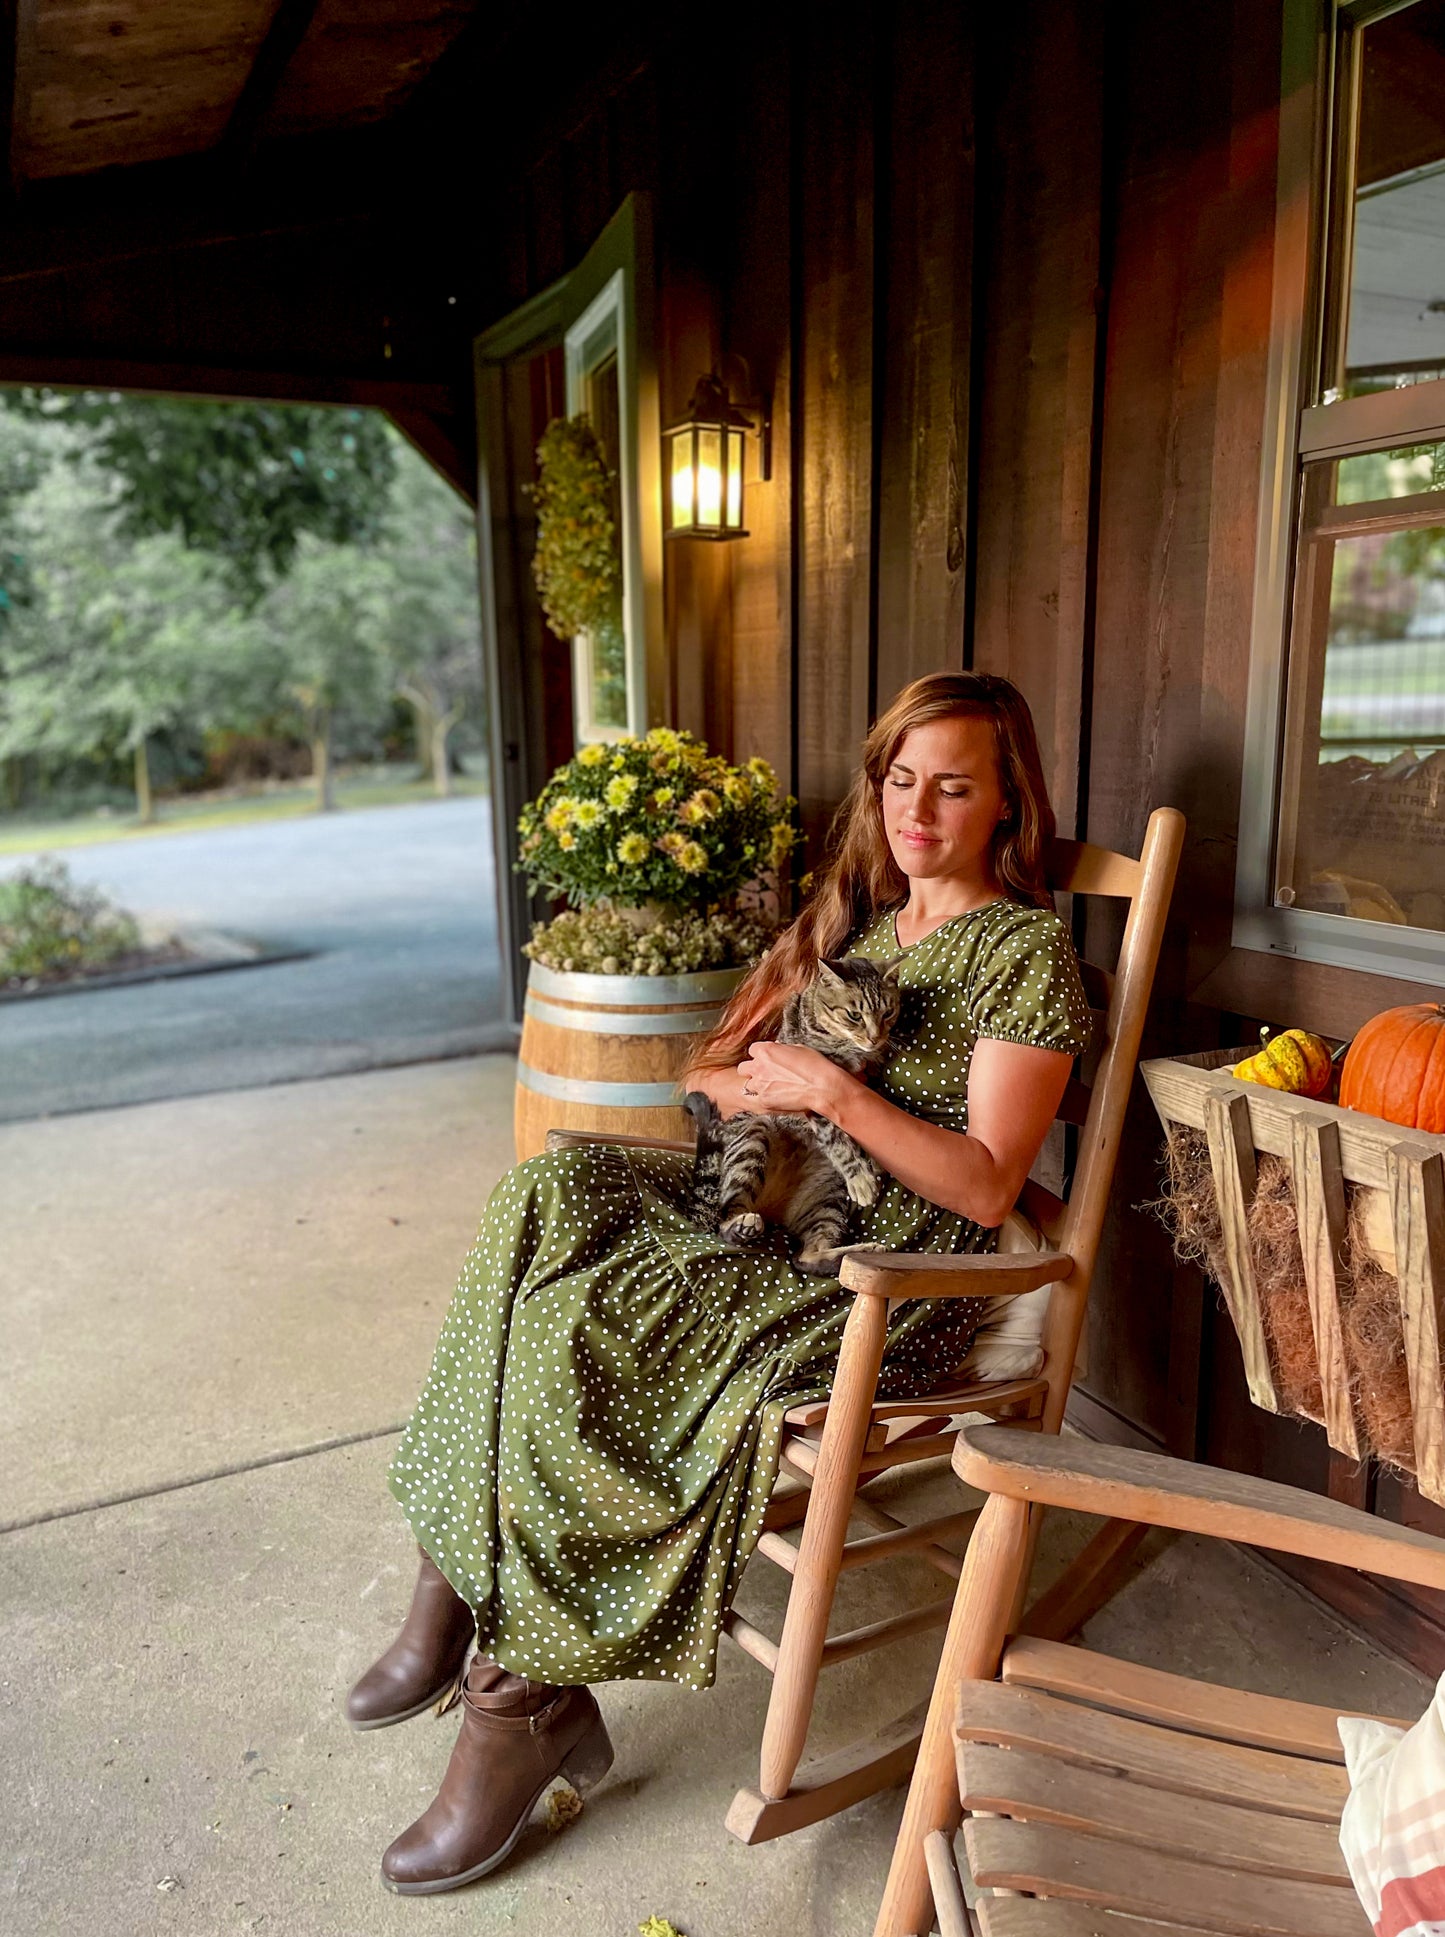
[548,808,1184,1844]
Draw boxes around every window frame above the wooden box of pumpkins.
[1232,0,1445,982]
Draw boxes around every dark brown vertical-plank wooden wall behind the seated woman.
[472,0,1288,1464]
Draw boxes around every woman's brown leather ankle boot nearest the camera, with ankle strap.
[382,1660,612,1896]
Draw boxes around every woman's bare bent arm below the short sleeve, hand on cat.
[736,1036,1073,1228]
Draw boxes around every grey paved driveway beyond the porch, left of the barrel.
[0,800,506,1122]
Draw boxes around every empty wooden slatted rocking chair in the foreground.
[876,1426,1445,1937]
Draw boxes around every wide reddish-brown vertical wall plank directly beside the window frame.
[1087,0,1290,1451]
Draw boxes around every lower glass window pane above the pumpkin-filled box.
[1276,507,1445,930]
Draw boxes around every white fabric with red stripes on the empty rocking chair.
[1338,1676,1445,1937]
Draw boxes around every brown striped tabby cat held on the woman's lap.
[684,955,899,1278]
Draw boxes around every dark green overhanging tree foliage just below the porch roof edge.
[6,389,395,602]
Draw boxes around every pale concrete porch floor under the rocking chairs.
[0,1058,1430,1937]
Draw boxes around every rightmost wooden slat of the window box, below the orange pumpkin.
[1385,1143,1445,1501]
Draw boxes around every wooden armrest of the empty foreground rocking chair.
[953,1426,1445,1588]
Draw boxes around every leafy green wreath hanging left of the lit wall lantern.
[376,449,482,796]
